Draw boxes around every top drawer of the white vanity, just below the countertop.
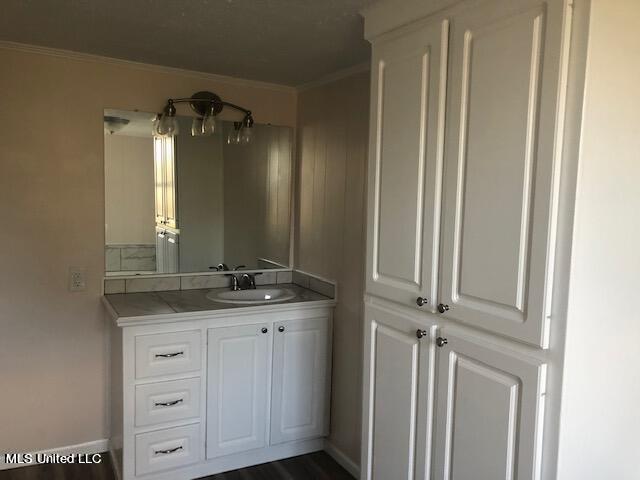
[135,330,201,379]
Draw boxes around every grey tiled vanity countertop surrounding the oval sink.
[103,283,335,325]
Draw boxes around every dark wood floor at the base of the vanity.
[0,452,353,480]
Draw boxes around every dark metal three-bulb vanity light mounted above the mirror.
[153,91,253,144]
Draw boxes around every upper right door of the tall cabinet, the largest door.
[440,0,563,347]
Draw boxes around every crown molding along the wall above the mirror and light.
[0,40,297,93]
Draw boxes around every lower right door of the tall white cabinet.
[434,335,546,480]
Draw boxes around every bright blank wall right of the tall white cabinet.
[557,0,640,480]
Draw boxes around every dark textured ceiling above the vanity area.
[0,0,373,85]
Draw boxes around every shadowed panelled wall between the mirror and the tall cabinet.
[295,72,369,464]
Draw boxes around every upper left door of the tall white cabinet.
[367,18,448,308]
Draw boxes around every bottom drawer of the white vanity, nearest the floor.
[136,424,200,476]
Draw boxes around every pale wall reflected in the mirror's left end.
[104,133,156,245]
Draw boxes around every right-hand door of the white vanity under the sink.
[271,317,331,444]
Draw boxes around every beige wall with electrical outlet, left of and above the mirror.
[0,43,296,451]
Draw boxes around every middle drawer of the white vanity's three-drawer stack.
[135,377,200,427]
